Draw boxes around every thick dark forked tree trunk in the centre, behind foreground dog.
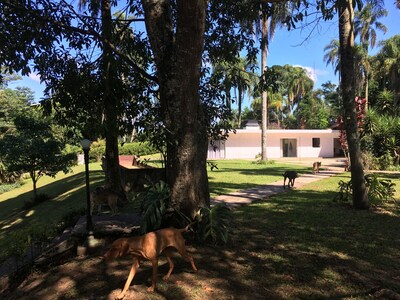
[142,0,210,217]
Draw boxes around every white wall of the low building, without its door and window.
[221,129,340,159]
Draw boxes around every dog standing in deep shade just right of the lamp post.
[90,186,120,215]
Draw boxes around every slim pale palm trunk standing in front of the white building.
[261,9,268,160]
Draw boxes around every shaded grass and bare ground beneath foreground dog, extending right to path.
[4,174,400,299]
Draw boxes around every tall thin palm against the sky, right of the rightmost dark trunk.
[354,1,388,109]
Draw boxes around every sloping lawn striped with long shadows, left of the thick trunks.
[0,164,104,260]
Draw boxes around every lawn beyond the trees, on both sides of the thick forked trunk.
[0,160,310,260]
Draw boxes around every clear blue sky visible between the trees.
[10,0,400,105]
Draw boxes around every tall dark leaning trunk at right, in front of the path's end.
[339,0,369,209]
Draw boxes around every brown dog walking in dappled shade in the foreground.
[104,225,197,299]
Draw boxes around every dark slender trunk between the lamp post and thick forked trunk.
[101,0,122,192]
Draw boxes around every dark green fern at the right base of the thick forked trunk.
[196,203,232,244]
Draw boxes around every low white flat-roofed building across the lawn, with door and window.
[208,121,342,159]
